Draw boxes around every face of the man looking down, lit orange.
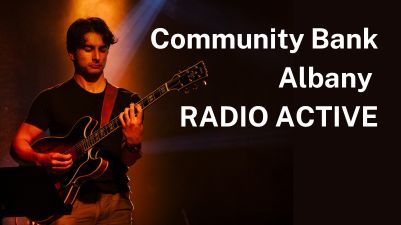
[69,32,109,78]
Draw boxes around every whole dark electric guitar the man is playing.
[29,61,208,224]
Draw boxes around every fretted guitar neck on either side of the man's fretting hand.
[75,83,170,152]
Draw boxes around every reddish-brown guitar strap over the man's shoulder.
[100,82,118,127]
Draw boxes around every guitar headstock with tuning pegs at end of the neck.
[167,61,208,93]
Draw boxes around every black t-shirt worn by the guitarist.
[25,79,139,195]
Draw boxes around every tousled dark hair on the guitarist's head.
[67,17,117,53]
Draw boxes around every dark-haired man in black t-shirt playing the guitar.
[12,18,143,224]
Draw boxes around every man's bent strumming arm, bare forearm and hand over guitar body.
[11,123,72,172]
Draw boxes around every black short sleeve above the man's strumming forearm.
[25,90,50,130]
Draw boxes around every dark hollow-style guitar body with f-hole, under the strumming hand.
[30,116,109,224]
